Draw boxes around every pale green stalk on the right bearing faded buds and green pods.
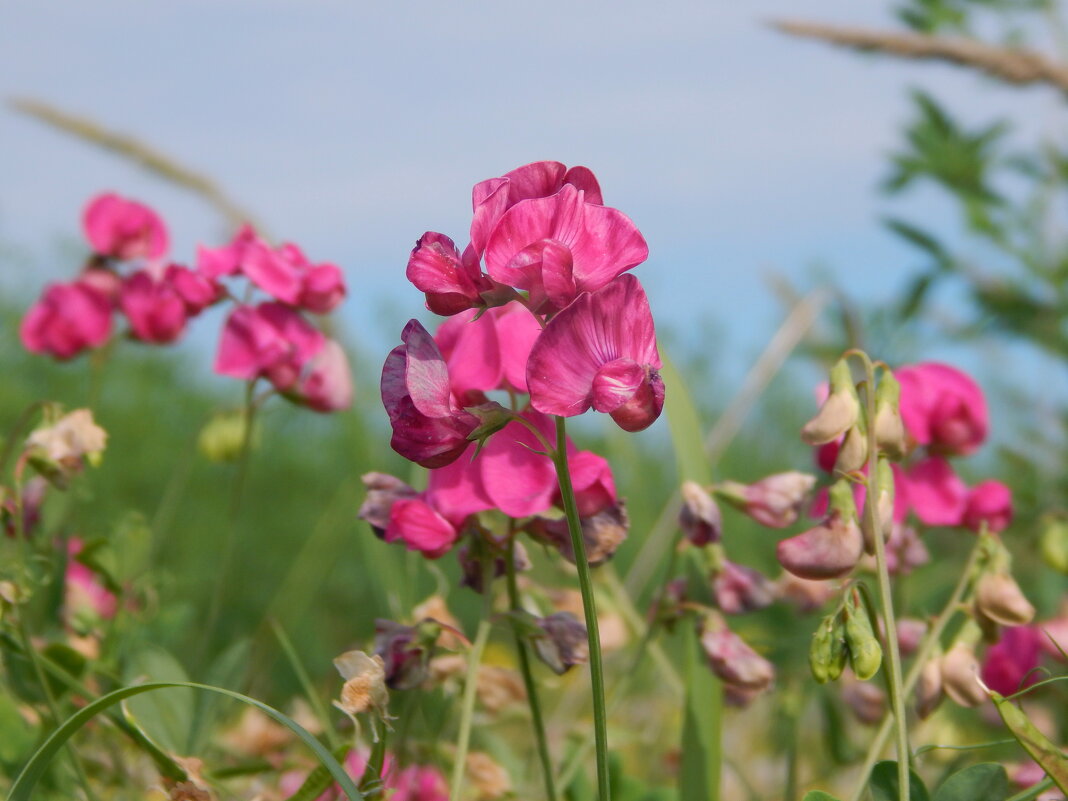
[861,354,910,801]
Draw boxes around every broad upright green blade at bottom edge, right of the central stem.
[678,626,723,801]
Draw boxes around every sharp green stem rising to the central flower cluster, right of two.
[552,417,612,801]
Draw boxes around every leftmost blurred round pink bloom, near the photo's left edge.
[19,281,111,359]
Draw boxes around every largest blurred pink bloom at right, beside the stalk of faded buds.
[894,362,989,455]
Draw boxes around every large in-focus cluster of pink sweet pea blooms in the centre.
[360,161,663,572]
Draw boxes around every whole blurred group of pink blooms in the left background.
[20,193,352,412]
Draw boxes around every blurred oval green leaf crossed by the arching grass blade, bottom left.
[124,647,197,754]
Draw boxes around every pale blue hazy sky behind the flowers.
[0,0,1068,420]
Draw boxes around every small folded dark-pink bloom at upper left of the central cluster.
[405,231,493,317]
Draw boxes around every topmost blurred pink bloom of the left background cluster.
[82,192,168,261]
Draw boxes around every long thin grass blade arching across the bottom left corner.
[7,681,363,801]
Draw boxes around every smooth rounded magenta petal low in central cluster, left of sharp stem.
[475,412,557,517]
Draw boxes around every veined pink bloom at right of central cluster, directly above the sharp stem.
[527,276,664,431]
